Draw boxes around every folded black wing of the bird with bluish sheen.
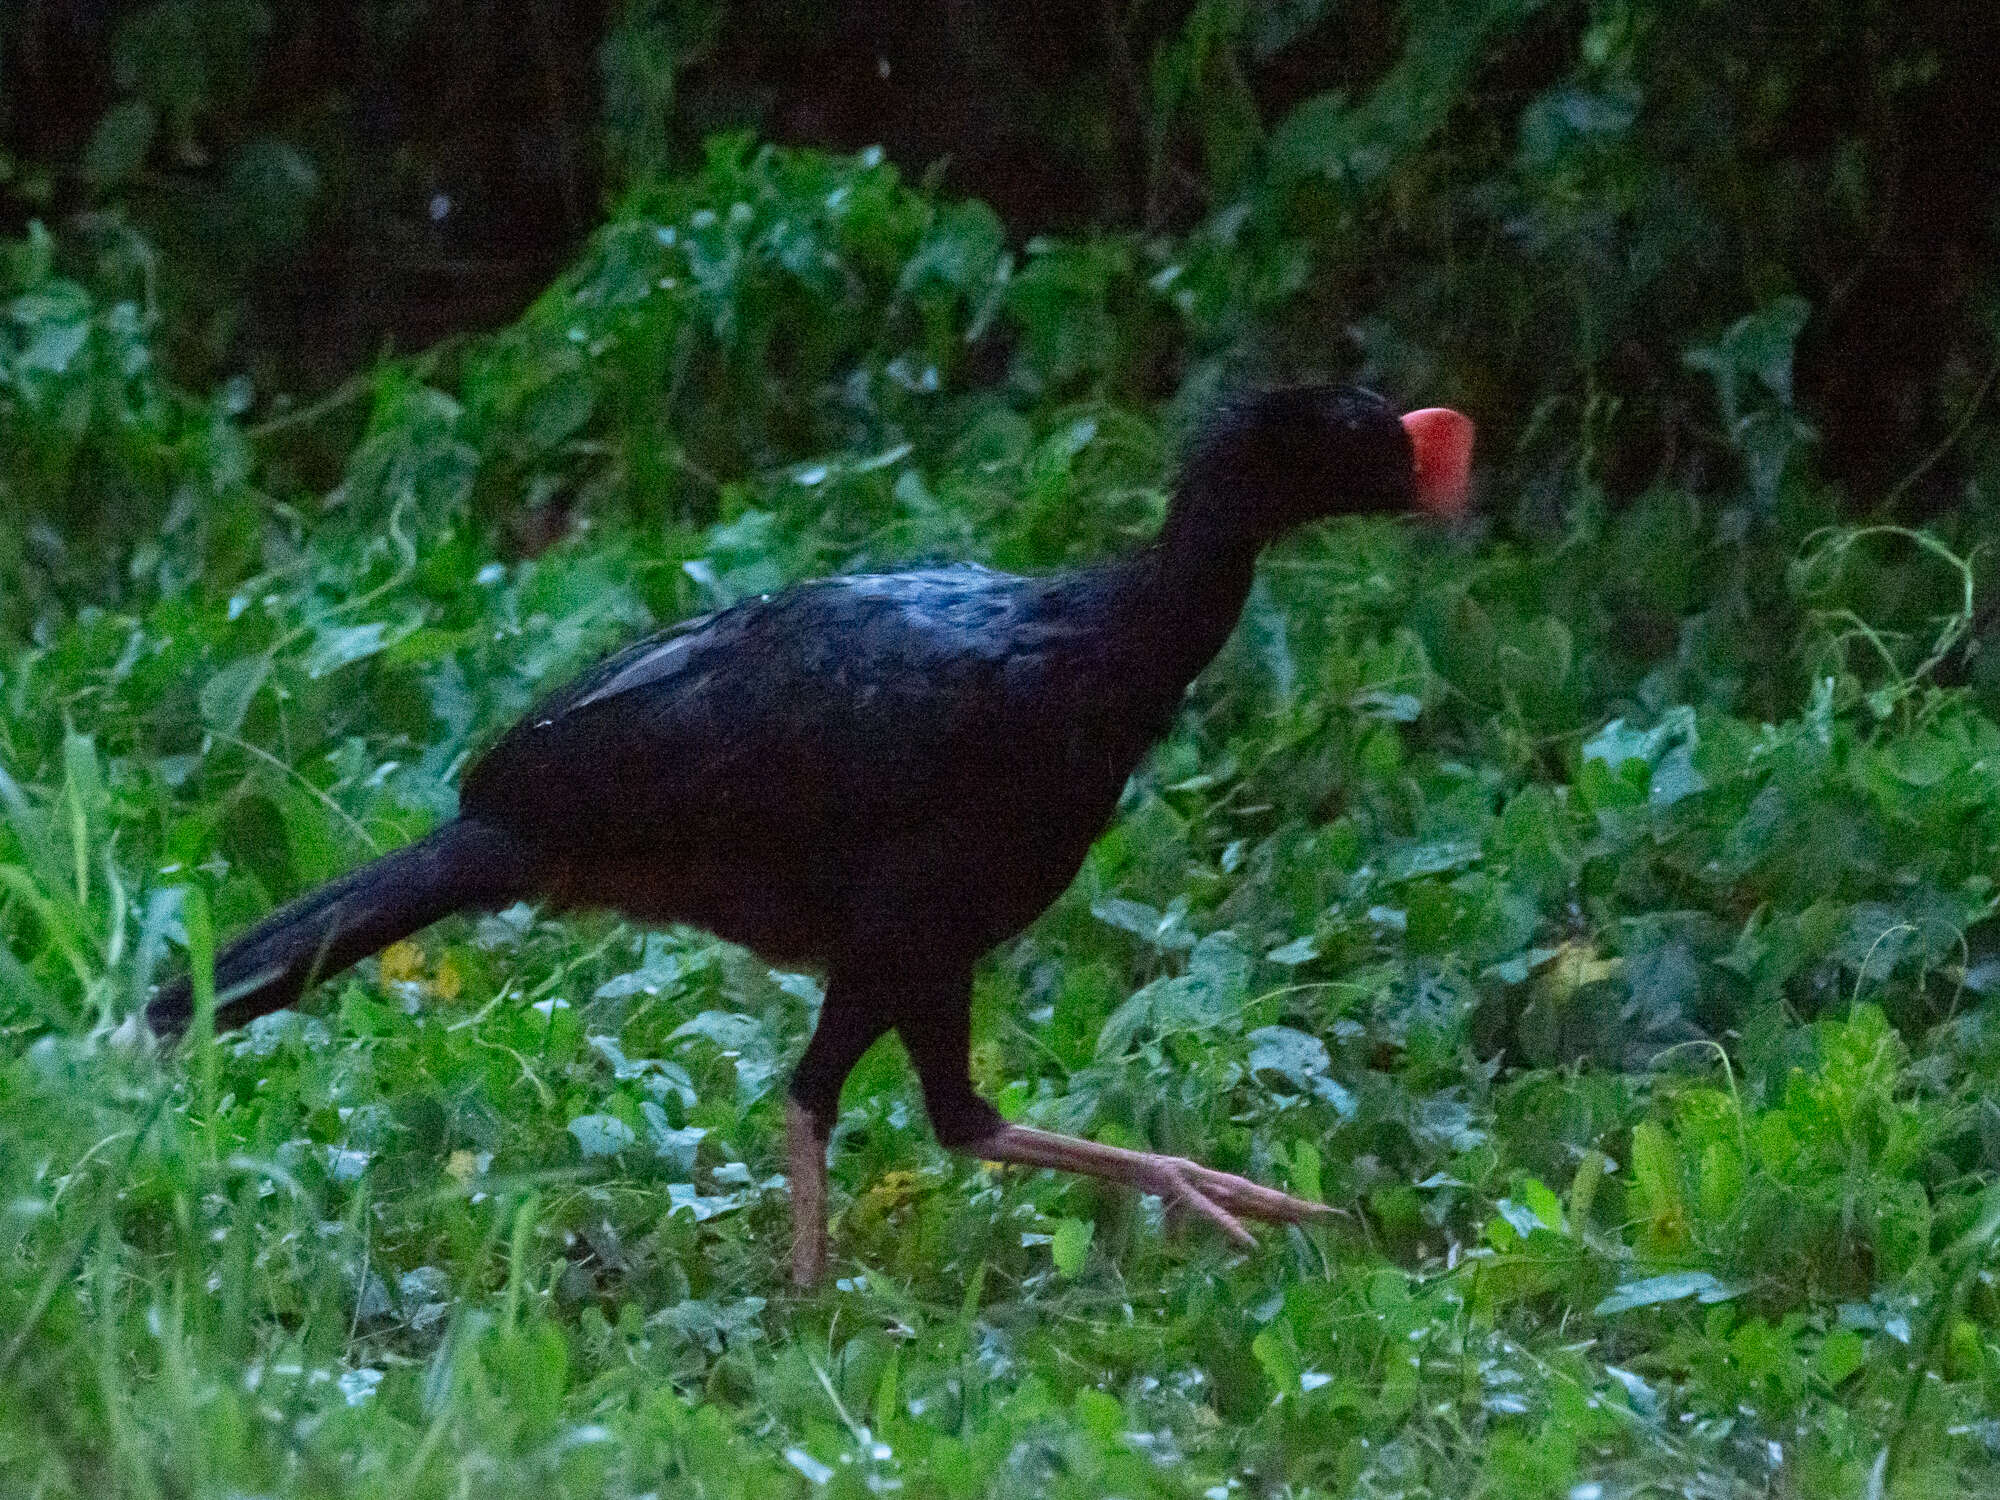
[462,568,1064,850]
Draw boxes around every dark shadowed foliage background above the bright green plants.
[0,0,2000,512]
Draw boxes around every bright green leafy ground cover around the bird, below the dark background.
[0,138,2000,1500]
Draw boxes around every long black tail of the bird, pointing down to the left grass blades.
[146,818,534,1038]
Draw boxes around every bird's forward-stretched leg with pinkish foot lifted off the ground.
[896,978,1336,1246]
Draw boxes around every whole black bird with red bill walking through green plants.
[146,384,1472,1288]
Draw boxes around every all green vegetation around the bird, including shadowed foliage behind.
[0,0,2000,1500]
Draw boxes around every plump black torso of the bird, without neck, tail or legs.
[462,566,1172,962]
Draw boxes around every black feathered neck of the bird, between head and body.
[1122,502,1262,702]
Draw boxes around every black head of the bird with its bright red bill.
[1182,386,1472,542]
